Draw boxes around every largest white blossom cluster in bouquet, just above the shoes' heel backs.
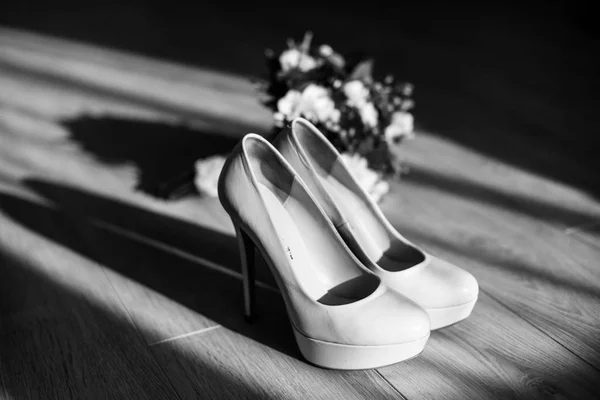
[277,84,340,126]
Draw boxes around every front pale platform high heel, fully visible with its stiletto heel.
[219,134,429,369]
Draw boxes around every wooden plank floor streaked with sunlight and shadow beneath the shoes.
[0,29,600,399]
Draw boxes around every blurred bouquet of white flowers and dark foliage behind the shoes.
[261,33,414,200]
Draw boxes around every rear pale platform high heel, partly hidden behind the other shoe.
[274,118,479,330]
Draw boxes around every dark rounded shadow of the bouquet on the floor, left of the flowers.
[62,117,239,199]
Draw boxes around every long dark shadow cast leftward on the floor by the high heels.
[11,179,301,359]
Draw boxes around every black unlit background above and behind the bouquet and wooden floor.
[0,0,600,195]
